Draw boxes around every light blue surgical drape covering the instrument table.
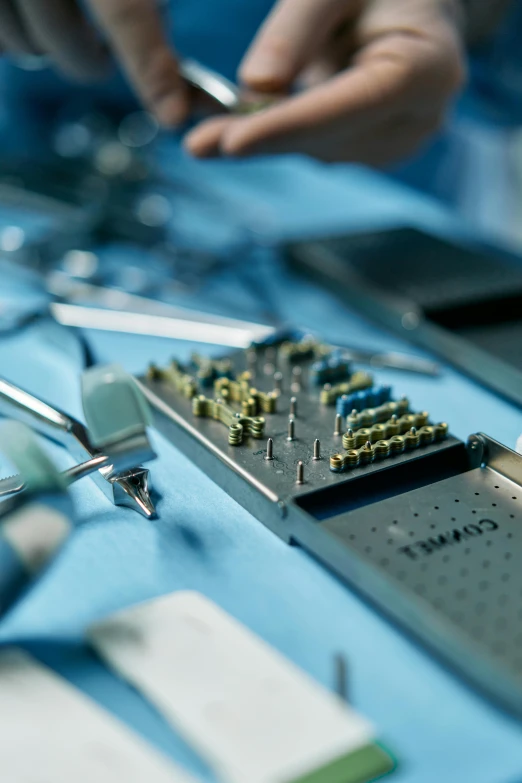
[0,182,522,783]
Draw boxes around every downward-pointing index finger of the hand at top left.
[90,0,188,126]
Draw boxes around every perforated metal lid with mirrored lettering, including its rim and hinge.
[322,435,522,714]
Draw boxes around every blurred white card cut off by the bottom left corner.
[0,648,194,783]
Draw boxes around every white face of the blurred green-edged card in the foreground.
[89,592,374,783]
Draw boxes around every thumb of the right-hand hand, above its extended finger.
[239,0,360,92]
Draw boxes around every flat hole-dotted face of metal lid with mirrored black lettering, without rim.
[340,470,522,685]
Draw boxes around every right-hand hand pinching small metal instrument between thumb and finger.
[185,0,465,165]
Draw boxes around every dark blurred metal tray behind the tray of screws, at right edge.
[285,229,522,405]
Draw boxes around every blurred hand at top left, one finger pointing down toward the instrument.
[0,0,188,127]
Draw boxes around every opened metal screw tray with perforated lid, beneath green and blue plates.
[140,352,522,715]
